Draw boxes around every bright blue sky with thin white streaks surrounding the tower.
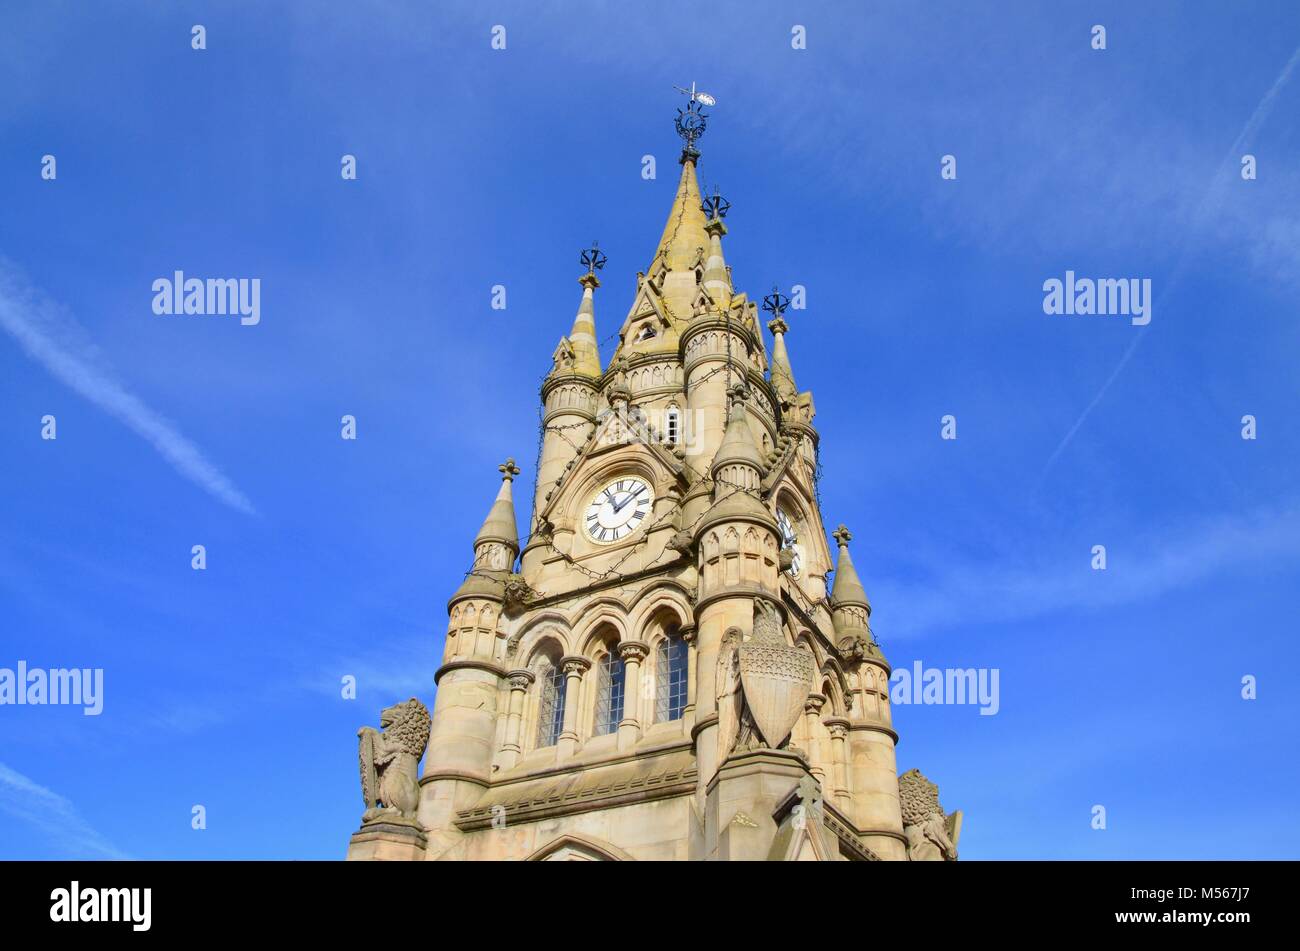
[0,3,1300,859]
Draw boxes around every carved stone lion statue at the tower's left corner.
[356,696,432,822]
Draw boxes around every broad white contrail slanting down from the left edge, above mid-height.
[0,259,256,514]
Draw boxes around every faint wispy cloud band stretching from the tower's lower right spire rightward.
[871,507,1300,639]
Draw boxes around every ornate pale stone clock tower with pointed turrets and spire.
[348,100,959,860]
